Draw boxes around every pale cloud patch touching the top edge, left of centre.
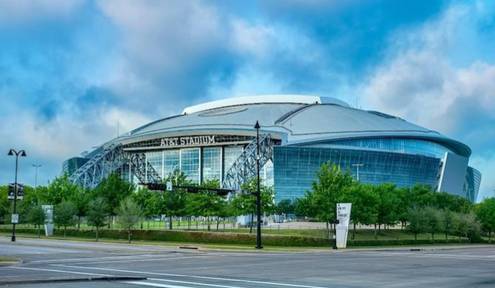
[98,0,224,73]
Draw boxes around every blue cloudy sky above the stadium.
[0,0,495,198]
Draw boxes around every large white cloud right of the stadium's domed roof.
[360,6,495,197]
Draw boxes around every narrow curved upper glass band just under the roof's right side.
[312,138,454,158]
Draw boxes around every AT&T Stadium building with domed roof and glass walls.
[63,95,481,202]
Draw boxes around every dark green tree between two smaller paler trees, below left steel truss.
[93,173,134,224]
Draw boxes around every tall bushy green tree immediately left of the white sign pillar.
[308,163,354,239]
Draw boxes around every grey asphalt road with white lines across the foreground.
[0,237,495,288]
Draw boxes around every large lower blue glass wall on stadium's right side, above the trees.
[273,146,440,202]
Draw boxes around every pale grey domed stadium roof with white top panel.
[112,95,471,156]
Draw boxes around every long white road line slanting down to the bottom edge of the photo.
[52,264,326,288]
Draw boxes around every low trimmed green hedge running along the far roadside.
[0,228,485,247]
